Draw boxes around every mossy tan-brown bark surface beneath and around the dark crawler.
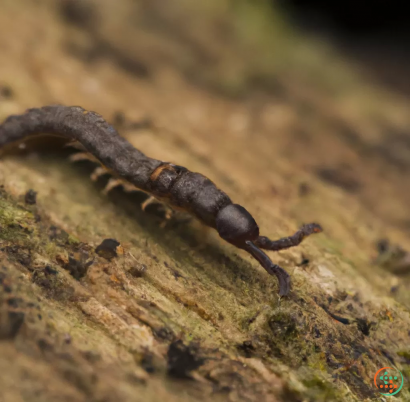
[0,0,410,402]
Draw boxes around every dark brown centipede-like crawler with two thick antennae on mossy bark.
[0,105,322,296]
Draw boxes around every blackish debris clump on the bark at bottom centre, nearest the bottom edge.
[167,340,204,378]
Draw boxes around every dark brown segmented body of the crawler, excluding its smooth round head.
[0,105,232,228]
